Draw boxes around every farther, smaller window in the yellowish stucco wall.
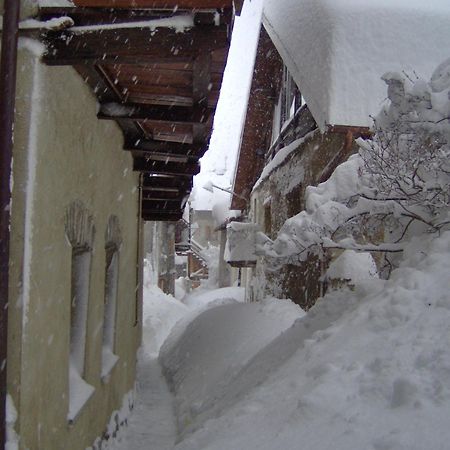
[102,216,122,377]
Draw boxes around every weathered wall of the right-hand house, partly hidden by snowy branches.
[246,131,356,309]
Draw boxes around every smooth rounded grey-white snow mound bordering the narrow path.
[160,299,303,438]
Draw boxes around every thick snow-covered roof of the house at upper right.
[264,0,450,129]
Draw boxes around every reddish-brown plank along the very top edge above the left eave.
[74,0,232,10]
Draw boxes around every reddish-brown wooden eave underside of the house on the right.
[231,26,283,210]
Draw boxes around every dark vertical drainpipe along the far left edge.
[0,0,20,449]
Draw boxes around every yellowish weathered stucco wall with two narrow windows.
[8,45,141,450]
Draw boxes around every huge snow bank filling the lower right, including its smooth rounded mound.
[173,232,450,450]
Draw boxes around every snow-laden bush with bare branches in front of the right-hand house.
[259,59,450,272]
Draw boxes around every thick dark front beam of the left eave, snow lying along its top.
[43,26,229,65]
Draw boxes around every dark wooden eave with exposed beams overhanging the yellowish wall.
[40,0,234,220]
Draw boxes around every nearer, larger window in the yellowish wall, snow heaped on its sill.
[65,201,95,422]
